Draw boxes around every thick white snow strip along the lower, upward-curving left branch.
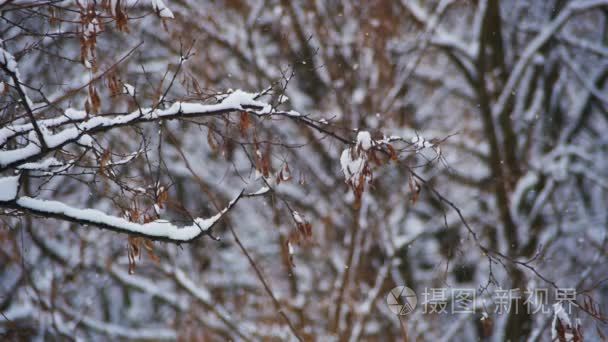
[0,182,267,243]
